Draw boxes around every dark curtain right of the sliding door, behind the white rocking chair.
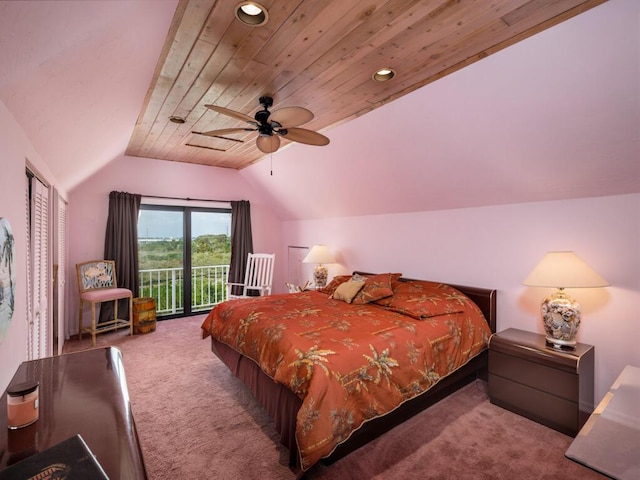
[229,200,253,295]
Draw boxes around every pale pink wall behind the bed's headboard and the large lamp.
[283,194,640,402]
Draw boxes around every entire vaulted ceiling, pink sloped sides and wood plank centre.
[0,0,640,220]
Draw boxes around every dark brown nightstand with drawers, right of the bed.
[489,328,595,437]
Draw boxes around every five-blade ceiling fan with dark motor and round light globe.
[193,97,329,153]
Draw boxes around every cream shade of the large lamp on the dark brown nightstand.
[522,252,609,288]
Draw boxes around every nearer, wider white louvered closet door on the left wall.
[27,176,53,360]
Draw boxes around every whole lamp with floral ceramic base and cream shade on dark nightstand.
[522,252,609,348]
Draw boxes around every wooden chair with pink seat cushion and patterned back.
[76,260,133,347]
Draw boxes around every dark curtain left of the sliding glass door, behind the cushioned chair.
[100,192,142,322]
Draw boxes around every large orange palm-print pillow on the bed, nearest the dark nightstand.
[374,280,464,320]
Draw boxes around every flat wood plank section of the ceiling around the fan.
[126,0,605,169]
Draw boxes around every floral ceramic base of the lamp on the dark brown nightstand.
[541,290,581,348]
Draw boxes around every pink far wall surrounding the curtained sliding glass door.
[67,156,286,333]
